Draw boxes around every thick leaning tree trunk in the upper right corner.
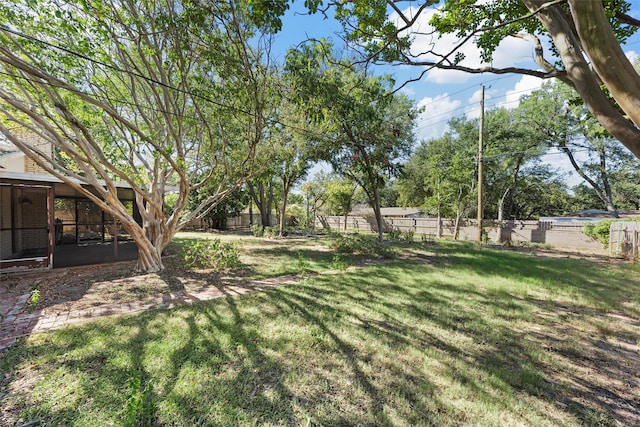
[523,0,640,158]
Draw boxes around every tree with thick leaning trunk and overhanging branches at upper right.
[306,0,640,158]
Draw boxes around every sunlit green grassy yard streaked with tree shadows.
[0,236,640,426]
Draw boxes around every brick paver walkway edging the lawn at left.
[0,275,298,350]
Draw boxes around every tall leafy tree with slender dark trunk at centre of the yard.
[286,41,417,240]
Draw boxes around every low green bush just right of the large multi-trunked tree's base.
[180,239,240,271]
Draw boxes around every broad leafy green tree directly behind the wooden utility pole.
[398,109,567,230]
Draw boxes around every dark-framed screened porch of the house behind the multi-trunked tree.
[0,170,140,271]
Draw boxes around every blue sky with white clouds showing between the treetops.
[275,2,640,185]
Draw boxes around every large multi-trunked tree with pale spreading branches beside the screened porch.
[0,0,269,272]
